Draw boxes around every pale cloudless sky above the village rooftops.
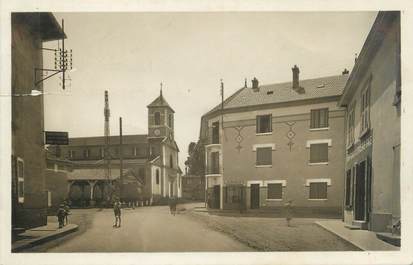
[44,12,377,168]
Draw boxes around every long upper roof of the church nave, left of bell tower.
[69,134,148,146]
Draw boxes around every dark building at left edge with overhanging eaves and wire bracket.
[11,13,65,230]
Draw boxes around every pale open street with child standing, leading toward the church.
[30,206,253,252]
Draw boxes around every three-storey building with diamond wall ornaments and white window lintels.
[200,66,348,214]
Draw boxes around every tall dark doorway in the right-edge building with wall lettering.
[354,161,366,221]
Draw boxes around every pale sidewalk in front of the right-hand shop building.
[315,220,400,251]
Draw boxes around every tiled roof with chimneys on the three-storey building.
[209,75,348,113]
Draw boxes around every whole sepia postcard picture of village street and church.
[0,1,412,264]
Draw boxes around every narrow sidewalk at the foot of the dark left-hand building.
[12,222,78,252]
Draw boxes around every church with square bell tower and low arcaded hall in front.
[47,91,182,207]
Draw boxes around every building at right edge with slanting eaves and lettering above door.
[339,12,401,236]
